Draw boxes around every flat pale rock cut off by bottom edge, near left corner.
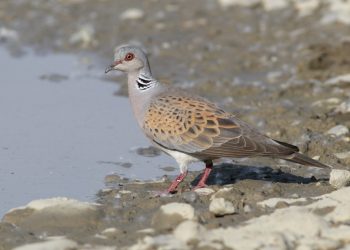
[13,237,78,250]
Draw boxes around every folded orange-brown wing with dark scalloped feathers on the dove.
[143,93,297,159]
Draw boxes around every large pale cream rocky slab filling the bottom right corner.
[127,187,350,250]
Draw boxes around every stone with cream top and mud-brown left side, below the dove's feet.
[152,202,195,229]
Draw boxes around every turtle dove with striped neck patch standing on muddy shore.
[105,45,331,194]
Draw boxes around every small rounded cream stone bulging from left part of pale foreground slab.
[174,220,205,243]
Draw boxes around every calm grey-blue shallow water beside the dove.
[0,48,201,215]
